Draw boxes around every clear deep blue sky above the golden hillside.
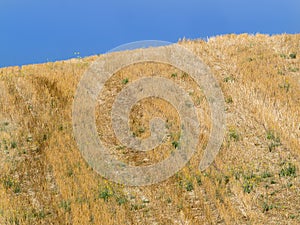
[0,0,300,67]
